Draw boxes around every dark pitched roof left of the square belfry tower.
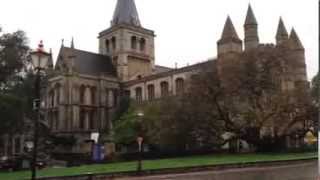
[58,47,116,76]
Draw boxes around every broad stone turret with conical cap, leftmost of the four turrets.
[218,16,242,57]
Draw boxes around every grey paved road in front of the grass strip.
[117,162,317,180]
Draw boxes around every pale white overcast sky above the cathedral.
[0,0,318,79]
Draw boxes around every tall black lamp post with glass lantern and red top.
[30,41,50,180]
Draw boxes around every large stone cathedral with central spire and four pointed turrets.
[45,0,307,153]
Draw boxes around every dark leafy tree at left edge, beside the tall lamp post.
[0,31,34,134]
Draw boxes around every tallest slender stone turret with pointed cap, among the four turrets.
[244,4,259,50]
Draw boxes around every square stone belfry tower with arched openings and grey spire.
[99,0,155,81]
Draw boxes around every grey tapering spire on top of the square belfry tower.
[111,0,141,26]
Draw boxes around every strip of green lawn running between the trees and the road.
[0,153,317,180]
